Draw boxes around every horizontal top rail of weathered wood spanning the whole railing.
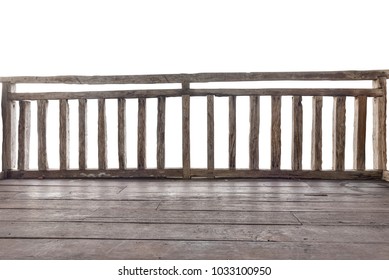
[0,70,389,84]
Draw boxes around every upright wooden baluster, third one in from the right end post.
[311,96,323,171]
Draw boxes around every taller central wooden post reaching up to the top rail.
[182,82,190,179]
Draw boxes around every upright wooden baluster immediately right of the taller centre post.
[207,95,215,173]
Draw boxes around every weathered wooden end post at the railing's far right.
[373,77,387,170]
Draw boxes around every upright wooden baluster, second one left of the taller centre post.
[138,98,146,169]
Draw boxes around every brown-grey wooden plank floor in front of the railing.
[0,179,389,259]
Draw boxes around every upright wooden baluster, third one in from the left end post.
[59,99,70,170]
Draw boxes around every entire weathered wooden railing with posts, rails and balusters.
[0,71,389,179]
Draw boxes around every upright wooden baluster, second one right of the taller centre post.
[228,96,236,169]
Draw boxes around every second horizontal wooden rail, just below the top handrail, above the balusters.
[11,88,383,100]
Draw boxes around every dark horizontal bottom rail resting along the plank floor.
[4,168,383,180]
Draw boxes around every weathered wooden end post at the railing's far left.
[1,83,16,174]
